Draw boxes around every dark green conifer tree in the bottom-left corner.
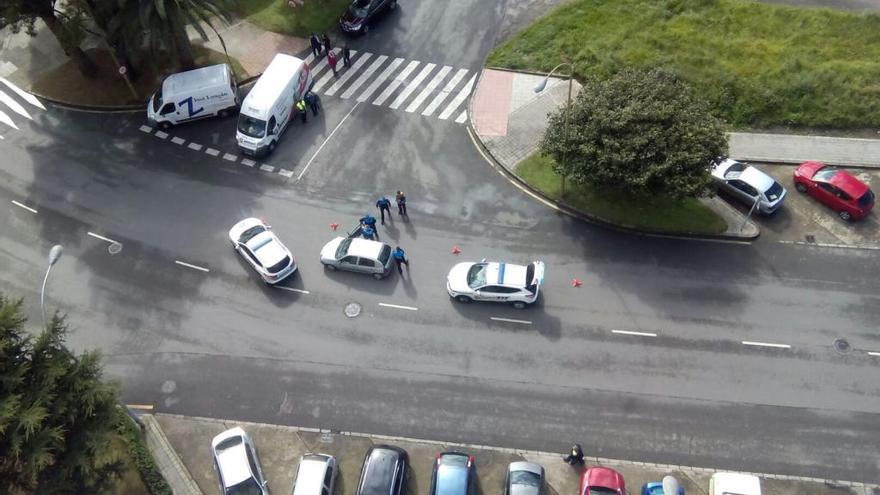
[0,294,124,494]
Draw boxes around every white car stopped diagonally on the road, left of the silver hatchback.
[229,218,296,284]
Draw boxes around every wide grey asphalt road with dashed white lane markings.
[0,2,880,481]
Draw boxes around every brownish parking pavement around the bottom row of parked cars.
[141,414,880,495]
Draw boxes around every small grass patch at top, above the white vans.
[238,0,351,38]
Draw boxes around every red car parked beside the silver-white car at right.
[794,162,874,220]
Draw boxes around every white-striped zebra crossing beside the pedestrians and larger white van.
[305,48,477,124]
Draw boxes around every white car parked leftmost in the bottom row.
[211,427,269,495]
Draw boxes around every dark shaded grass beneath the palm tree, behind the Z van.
[31,45,248,106]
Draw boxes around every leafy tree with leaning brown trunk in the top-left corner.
[0,0,98,77]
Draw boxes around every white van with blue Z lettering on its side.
[147,64,239,129]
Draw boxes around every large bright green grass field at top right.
[487,0,880,129]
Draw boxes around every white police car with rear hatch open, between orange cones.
[446,260,544,309]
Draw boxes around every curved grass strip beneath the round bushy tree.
[516,153,727,234]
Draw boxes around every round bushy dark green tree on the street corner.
[541,69,727,198]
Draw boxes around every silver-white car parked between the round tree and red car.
[710,157,786,215]
